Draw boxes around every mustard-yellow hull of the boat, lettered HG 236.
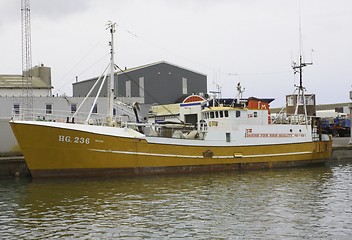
[10,122,332,177]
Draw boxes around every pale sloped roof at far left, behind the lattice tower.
[0,74,53,89]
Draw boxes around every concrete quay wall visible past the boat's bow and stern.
[0,137,352,178]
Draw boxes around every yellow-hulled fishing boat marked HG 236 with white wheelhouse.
[10,23,332,178]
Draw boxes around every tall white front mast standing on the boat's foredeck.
[106,22,116,125]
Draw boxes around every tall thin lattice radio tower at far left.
[21,0,33,118]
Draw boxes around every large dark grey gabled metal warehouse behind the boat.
[73,61,207,104]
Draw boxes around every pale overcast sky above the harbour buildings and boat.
[0,0,352,107]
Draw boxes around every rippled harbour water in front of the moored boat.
[0,161,352,239]
